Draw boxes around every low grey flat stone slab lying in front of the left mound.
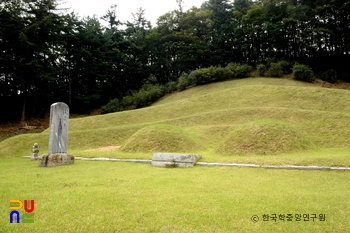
[152,152,202,167]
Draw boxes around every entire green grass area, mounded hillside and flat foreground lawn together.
[0,78,350,232]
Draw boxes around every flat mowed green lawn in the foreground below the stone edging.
[0,158,350,232]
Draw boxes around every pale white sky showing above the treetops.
[60,0,206,27]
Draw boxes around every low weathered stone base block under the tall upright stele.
[38,153,74,167]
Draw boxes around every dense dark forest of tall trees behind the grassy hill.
[0,0,350,123]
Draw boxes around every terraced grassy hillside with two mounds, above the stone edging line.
[0,78,350,166]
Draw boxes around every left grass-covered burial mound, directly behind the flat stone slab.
[120,124,204,153]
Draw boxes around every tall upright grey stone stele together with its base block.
[39,102,74,167]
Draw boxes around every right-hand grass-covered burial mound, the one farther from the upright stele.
[216,121,314,155]
